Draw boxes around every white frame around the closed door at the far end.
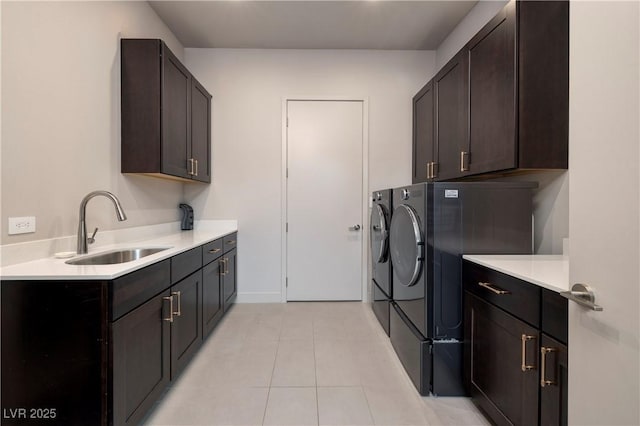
[280,96,369,303]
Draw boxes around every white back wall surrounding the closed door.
[185,49,435,301]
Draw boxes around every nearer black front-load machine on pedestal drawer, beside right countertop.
[389,182,537,396]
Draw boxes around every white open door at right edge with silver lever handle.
[568,1,640,425]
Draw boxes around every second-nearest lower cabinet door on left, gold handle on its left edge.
[171,270,202,380]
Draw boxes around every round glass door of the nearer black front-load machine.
[390,204,424,287]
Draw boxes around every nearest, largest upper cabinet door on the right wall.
[467,2,516,174]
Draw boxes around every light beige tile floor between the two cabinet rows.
[145,302,489,426]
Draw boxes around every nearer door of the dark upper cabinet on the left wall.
[161,44,191,178]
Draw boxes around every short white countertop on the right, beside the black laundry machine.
[462,254,570,292]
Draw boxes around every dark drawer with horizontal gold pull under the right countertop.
[463,260,540,327]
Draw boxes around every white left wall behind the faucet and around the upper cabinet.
[0,1,184,244]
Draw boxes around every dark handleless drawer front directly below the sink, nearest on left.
[109,259,171,321]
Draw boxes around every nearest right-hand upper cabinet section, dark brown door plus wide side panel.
[463,1,569,174]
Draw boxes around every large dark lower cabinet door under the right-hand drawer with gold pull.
[465,292,540,425]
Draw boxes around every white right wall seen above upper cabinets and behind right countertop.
[436,0,569,254]
